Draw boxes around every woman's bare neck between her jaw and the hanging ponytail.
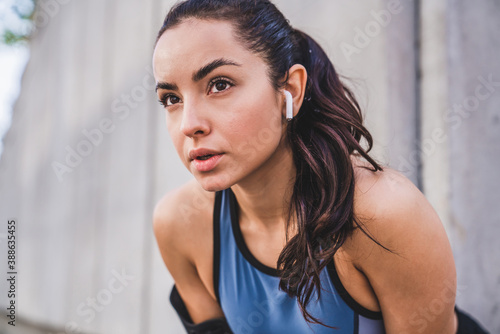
[231,140,296,231]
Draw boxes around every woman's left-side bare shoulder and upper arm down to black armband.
[153,179,224,324]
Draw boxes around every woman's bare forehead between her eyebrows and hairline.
[153,18,260,77]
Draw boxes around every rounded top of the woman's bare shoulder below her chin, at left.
[153,179,215,261]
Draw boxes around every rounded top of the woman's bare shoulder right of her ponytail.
[348,158,448,258]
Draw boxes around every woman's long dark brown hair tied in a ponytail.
[157,0,385,327]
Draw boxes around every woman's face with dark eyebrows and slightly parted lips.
[153,19,292,191]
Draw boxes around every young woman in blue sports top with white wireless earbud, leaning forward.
[153,0,488,334]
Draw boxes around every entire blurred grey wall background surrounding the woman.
[0,0,500,334]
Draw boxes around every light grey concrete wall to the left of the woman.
[0,0,184,333]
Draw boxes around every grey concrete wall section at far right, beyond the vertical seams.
[446,0,500,333]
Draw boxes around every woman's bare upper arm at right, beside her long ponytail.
[355,172,456,334]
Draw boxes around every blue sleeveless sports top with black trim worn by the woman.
[213,188,385,334]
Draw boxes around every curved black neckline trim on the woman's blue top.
[227,188,279,277]
